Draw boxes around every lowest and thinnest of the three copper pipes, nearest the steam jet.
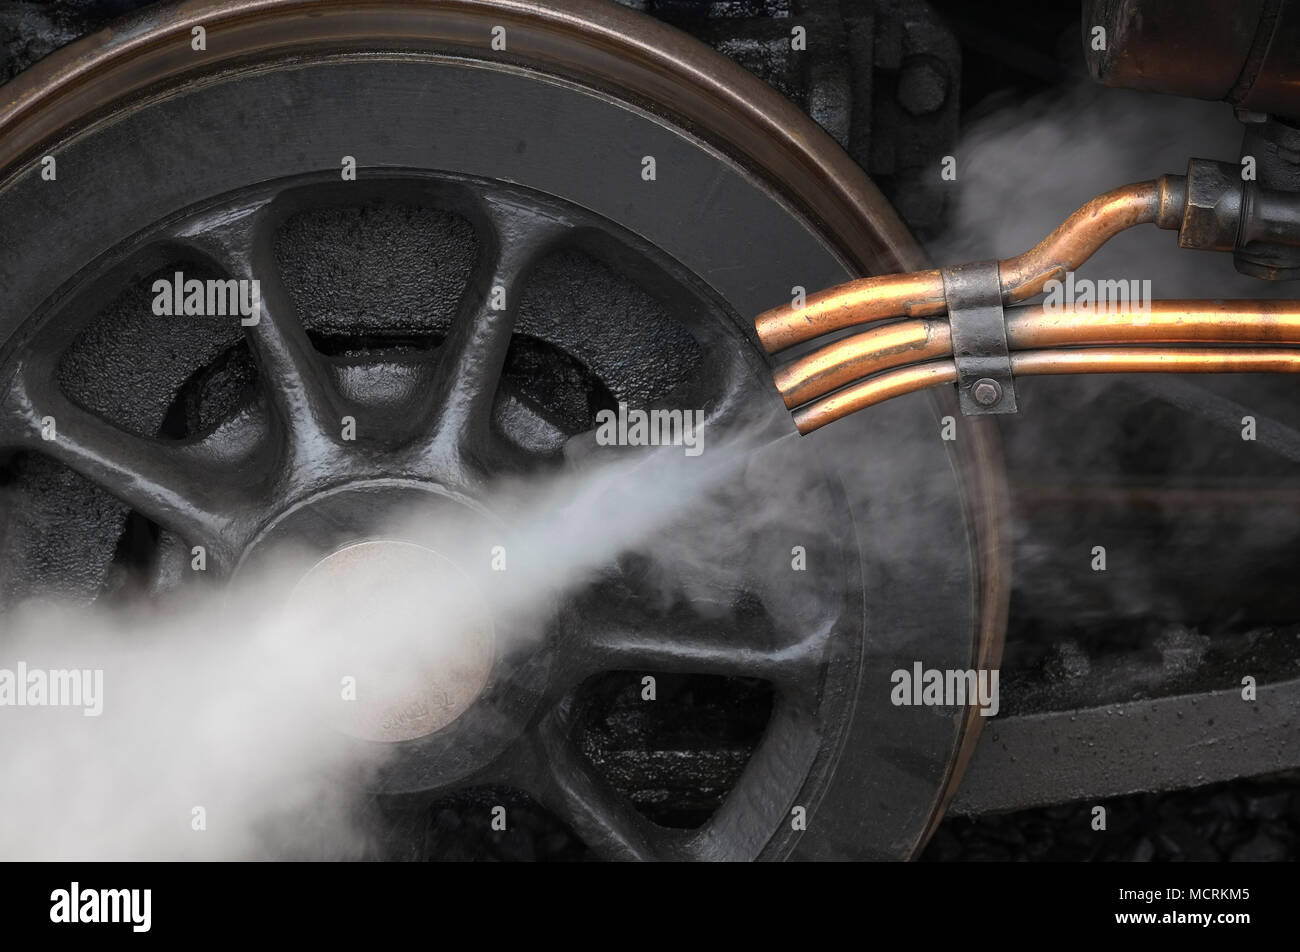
[794,347,1300,433]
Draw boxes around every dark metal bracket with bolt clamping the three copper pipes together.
[943,261,1019,416]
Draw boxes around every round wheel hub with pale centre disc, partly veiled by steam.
[234,479,533,764]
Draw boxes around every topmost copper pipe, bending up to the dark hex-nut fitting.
[754,176,1186,354]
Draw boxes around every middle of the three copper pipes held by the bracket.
[772,300,1300,407]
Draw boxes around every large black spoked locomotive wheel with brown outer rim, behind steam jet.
[0,0,1006,860]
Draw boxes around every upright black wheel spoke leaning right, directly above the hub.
[410,196,569,476]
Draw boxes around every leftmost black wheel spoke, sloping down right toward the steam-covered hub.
[0,365,230,549]
